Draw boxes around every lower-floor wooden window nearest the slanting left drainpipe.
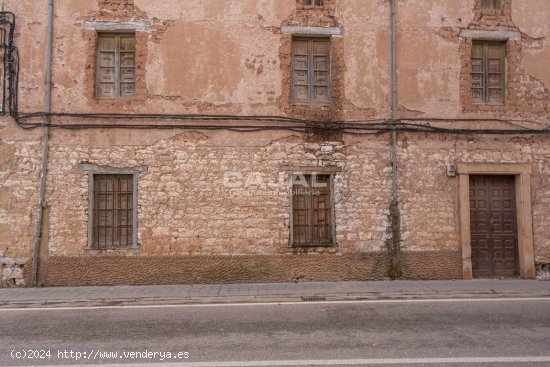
[92,175,133,249]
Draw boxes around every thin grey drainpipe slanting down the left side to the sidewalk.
[31,0,53,287]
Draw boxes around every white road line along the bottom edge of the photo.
[6,356,550,367]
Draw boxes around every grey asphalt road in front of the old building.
[0,299,550,367]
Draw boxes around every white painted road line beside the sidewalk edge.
[0,297,550,312]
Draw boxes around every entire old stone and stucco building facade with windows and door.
[0,0,550,286]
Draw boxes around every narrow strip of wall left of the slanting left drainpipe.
[0,1,47,287]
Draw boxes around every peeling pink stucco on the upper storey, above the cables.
[5,0,550,118]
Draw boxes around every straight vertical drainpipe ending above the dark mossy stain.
[390,0,397,203]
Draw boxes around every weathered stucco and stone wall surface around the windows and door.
[0,0,550,285]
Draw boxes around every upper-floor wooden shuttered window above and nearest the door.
[472,41,506,103]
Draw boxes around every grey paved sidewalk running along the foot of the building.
[0,279,550,308]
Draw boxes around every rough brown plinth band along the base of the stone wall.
[21,251,462,286]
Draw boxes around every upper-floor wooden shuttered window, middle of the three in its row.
[292,38,330,103]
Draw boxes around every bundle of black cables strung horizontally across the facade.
[0,12,550,135]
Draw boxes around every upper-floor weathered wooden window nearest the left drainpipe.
[96,33,136,98]
